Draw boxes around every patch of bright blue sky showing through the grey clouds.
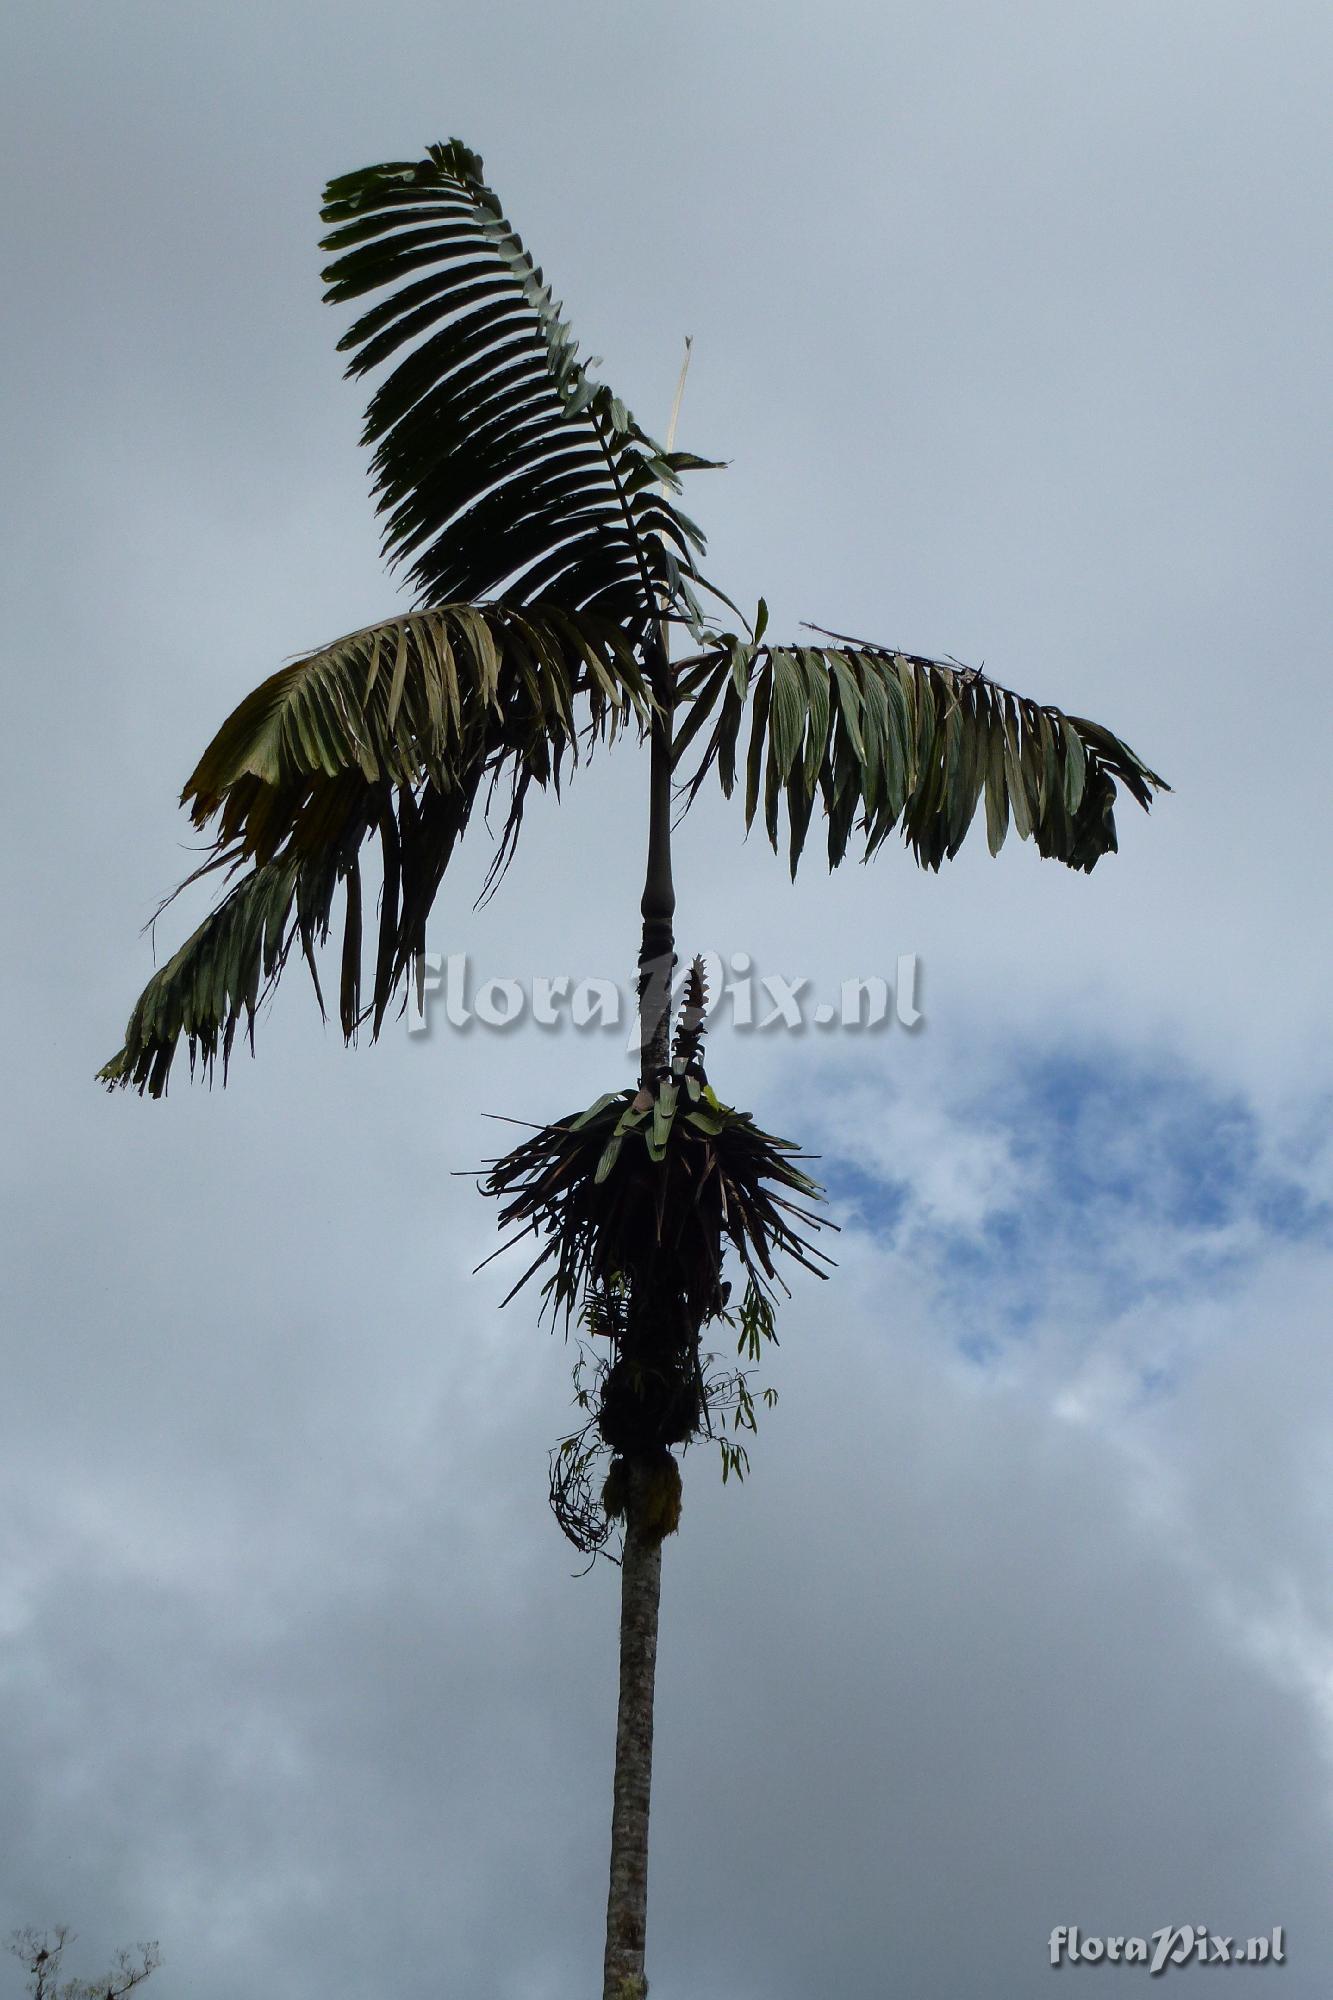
[811,1046,1333,1362]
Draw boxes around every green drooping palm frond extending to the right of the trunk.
[677,636,1169,876]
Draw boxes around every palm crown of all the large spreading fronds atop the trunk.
[100,140,1163,1096]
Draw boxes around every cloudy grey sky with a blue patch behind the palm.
[0,0,1333,2000]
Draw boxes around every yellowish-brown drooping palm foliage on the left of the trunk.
[100,604,650,1096]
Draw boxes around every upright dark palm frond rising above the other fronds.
[322,140,709,644]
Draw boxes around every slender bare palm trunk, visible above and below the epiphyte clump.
[602,640,677,2000]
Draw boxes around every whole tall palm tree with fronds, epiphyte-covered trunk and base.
[100,140,1163,2000]
